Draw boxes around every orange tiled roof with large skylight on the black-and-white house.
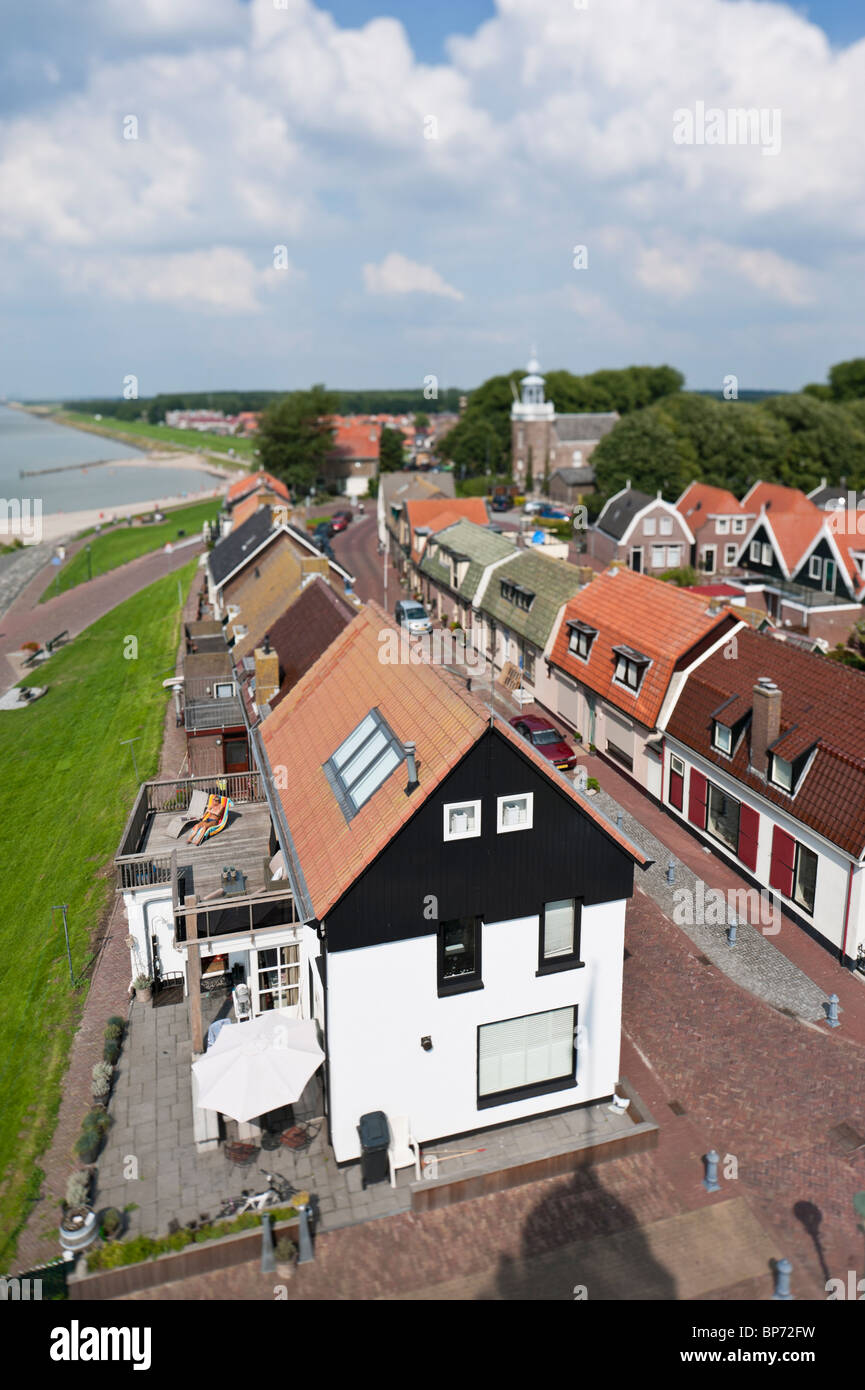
[260,603,648,920]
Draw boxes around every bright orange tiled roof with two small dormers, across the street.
[551,569,738,728]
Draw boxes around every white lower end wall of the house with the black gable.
[327,901,626,1162]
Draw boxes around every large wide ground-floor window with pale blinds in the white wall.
[477,1005,577,1109]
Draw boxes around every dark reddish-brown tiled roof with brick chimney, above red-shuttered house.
[666,628,865,859]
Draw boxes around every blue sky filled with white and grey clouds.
[0,0,865,399]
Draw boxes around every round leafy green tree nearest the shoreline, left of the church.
[256,385,335,492]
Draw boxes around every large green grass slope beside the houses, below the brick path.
[0,560,196,1269]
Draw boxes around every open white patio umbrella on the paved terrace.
[192,1009,324,1123]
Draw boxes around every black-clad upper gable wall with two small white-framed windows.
[327,730,634,951]
